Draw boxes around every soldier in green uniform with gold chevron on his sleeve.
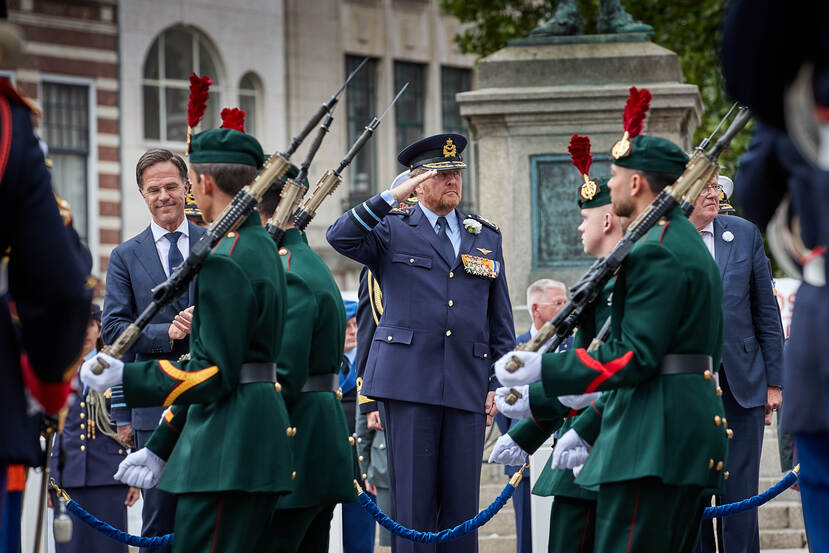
[81,129,293,553]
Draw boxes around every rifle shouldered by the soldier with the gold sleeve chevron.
[92,60,366,374]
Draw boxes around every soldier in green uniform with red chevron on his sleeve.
[496,136,728,553]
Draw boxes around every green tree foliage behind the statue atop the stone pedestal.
[441,0,751,175]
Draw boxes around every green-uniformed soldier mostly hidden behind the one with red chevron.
[490,157,622,553]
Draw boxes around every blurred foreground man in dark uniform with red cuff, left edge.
[0,64,91,518]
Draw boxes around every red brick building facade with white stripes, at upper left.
[7,0,123,272]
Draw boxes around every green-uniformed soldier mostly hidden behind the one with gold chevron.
[259,167,357,553]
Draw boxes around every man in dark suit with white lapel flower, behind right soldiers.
[690,170,783,553]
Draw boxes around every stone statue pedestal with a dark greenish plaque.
[457,42,703,332]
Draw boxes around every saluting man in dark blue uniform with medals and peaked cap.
[327,134,515,553]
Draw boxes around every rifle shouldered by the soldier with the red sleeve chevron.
[506,108,751,372]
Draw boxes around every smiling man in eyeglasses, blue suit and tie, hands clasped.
[103,148,204,552]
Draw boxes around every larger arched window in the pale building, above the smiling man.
[142,27,221,142]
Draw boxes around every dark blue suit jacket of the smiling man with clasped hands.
[102,222,204,430]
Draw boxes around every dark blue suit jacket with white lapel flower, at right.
[714,215,783,408]
